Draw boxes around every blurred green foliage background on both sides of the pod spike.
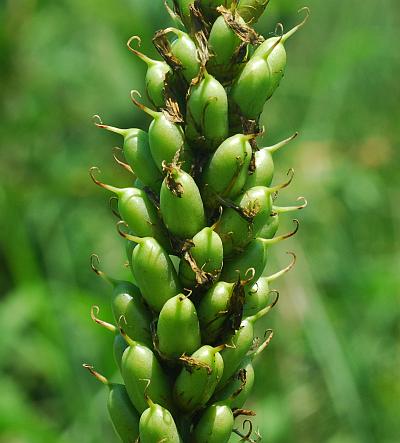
[0,0,400,443]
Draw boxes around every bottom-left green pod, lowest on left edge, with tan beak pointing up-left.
[83,364,139,443]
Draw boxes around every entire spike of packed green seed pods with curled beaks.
[85,0,308,443]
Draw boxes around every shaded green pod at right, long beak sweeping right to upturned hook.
[221,220,299,283]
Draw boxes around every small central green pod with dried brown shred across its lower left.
[178,227,224,289]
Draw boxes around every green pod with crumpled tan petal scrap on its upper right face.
[215,186,272,256]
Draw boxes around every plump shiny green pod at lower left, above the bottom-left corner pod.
[121,341,173,414]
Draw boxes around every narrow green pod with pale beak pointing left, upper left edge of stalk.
[95,116,162,193]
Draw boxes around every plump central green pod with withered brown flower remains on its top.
[160,166,206,241]
